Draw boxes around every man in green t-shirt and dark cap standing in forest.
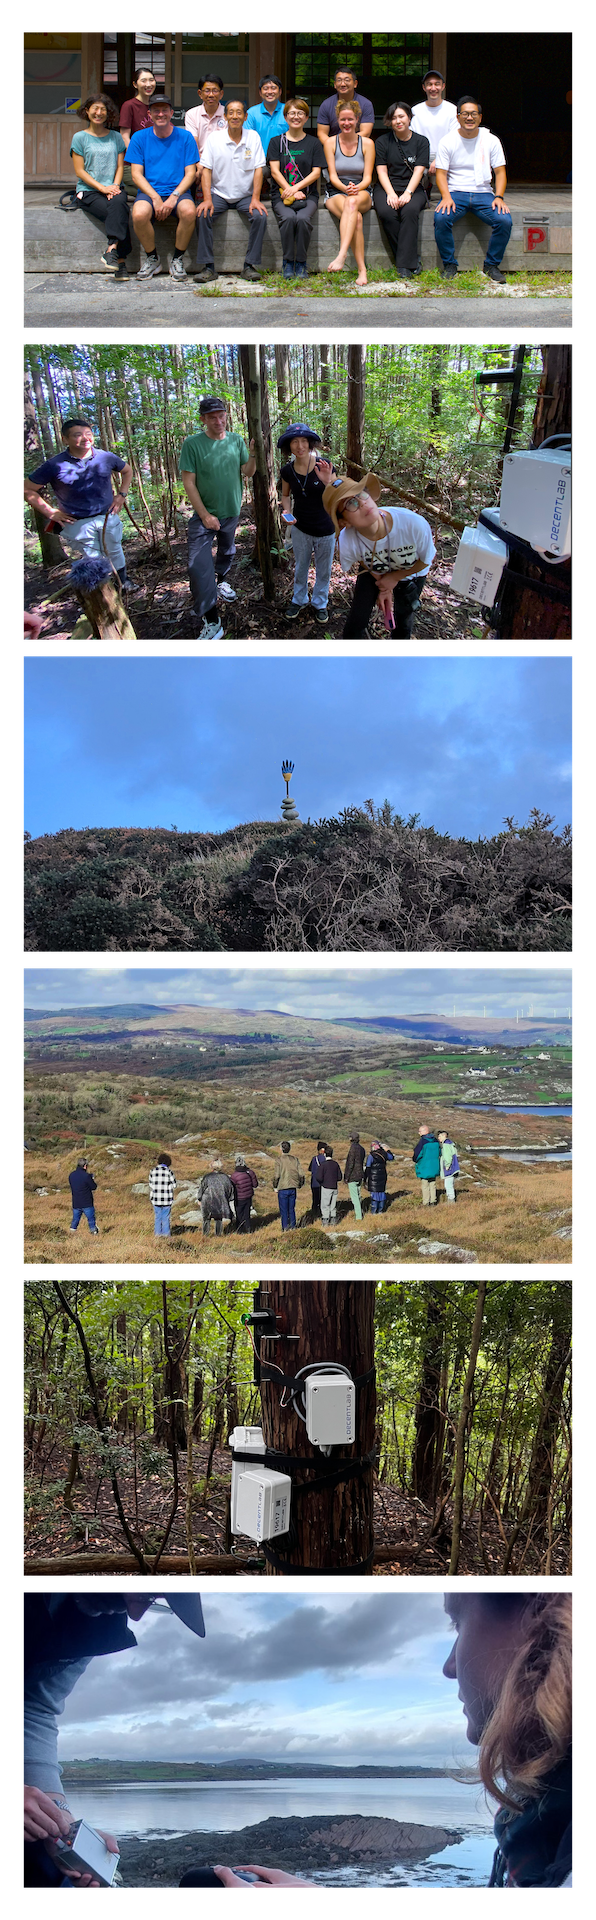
[181,396,256,645]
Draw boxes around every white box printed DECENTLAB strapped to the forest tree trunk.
[500,447,571,559]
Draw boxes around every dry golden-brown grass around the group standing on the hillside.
[23,1102,573,1269]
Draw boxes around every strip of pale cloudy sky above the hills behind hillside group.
[23,962,573,1020]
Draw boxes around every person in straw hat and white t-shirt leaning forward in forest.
[323,474,435,643]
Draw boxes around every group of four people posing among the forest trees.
[23,394,436,645]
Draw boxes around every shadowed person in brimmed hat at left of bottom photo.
[21,1584,206,1893]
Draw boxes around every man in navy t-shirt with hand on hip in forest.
[23,417,133,588]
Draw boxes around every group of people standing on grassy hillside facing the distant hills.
[69,1125,459,1240]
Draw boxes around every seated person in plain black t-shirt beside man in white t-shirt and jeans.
[373,100,431,280]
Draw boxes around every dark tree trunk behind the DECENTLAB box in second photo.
[498,340,571,647]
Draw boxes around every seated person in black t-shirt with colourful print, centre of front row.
[267,100,325,280]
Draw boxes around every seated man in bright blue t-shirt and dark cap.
[127,100,196,280]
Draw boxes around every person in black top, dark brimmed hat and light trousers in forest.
[277,420,335,626]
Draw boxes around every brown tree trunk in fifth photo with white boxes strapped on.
[253,1273,377,1582]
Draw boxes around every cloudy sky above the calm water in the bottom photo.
[60,1590,475,1766]
